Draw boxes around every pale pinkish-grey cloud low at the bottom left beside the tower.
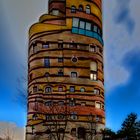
[0,122,25,140]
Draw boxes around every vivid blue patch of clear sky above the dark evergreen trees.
[106,49,140,130]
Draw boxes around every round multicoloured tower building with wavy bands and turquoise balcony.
[26,0,105,140]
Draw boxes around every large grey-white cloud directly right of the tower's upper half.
[104,0,140,91]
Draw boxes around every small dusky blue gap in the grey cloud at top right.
[115,0,135,34]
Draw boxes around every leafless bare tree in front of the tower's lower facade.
[30,90,70,140]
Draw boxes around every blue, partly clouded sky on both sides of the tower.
[0,0,140,130]
